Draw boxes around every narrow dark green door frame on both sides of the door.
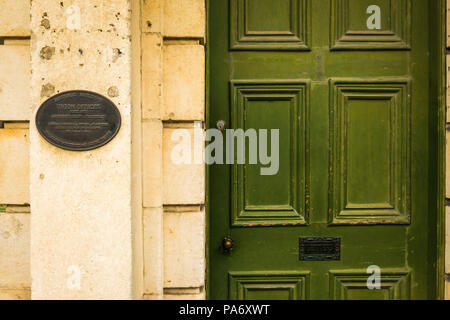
[205,0,450,300]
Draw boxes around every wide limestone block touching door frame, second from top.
[163,45,205,120]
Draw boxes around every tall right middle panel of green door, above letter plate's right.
[330,79,411,224]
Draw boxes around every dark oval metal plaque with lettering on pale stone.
[36,91,121,151]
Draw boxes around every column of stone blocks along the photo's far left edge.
[0,0,31,299]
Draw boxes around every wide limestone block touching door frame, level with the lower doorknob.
[164,212,205,288]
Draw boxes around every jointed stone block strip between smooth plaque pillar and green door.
[141,0,206,299]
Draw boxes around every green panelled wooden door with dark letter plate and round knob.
[207,0,436,300]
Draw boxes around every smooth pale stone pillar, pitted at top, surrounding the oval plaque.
[30,0,138,299]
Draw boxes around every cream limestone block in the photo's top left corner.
[0,0,30,36]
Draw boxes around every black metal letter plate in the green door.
[299,237,341,261]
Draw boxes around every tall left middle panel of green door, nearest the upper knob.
[231,81,309,227]
